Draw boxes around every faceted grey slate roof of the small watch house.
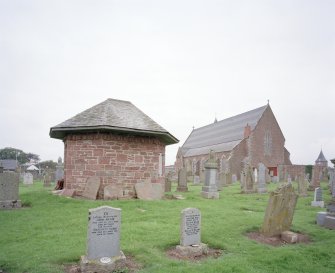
[50,99,178,145]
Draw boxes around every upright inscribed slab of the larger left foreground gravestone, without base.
[87,206,121,260]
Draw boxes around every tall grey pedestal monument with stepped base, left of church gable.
[201,151,219,199]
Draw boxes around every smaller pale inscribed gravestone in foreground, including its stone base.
[176,208,208,257]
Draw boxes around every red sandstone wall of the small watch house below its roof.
[64,133,165,196]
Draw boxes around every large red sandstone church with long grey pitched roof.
[175,104,292,178]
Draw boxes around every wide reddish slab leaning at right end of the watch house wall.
[135,181,164,200]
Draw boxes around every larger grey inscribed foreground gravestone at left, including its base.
[80,206,126,272]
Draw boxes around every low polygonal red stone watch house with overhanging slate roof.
[50,99,178,197]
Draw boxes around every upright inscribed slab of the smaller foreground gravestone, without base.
[180,208,201,246]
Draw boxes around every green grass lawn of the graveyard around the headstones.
[0,182,335,273]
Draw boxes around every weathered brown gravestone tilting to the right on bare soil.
[261,184,298,237]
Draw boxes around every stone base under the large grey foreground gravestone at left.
[80,251,126,273]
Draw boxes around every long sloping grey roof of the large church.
[181,104,269,157]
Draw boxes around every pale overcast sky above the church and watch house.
[0,0,335,164]
